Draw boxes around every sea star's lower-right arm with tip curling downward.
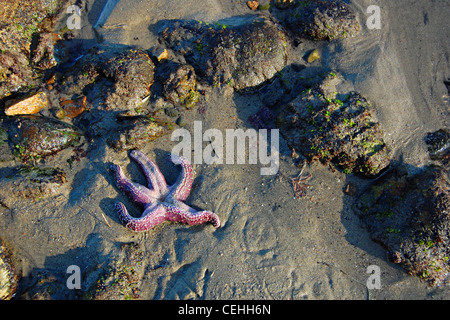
[163,203,220,229]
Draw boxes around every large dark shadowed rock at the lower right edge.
[355,166,450,286]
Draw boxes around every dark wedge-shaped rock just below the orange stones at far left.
[8,115,82,161]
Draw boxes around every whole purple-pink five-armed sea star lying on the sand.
[111,150,220,231]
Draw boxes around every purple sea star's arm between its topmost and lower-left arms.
[111,164,158,206]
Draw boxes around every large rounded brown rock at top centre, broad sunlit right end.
[159,15,288,90]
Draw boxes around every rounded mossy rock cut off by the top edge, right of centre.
[274,0,361,40]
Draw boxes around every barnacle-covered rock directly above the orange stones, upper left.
[63,46,155,115]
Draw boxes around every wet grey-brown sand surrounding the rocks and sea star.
[0,0,450,300]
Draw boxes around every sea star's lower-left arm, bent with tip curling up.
[115,202,167,231]
